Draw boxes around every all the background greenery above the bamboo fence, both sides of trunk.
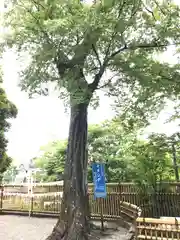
[35,119,180,190]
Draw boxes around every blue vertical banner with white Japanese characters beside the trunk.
[92,163,106,198]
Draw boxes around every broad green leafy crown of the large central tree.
[2,0,180,120]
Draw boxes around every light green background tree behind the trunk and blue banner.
[33,120,135,182]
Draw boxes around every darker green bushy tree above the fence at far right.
[132,134,174,189]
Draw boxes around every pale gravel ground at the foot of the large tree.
[0,215,127,240]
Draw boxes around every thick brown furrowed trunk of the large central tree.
[47,103,90,240]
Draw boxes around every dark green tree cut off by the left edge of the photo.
[0,75,17,181]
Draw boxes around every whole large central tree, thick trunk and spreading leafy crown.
[2,0,180,240]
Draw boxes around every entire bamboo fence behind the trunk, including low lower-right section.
[0,183,180,240]
